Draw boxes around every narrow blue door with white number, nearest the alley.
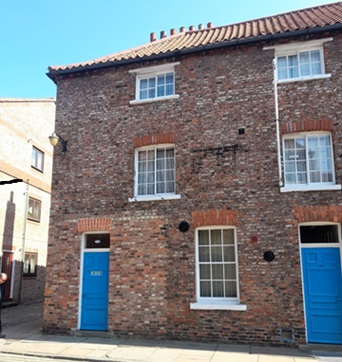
[80,252,109,331]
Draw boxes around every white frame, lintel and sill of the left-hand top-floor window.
[129,62,180,105]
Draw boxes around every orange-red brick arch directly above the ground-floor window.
[192,209,237,227]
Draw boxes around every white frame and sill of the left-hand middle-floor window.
[129,143,180,202]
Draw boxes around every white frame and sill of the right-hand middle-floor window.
[281,131,341,192]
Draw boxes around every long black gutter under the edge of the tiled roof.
[46,23,342,81]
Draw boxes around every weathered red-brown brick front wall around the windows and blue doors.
[44,35,342,344]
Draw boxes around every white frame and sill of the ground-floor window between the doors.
[190,225,247,311]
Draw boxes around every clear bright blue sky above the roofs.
[0,0,334,98]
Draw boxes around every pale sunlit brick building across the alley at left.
[0,98,55,303]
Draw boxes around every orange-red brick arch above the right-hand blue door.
[295,205,342,223]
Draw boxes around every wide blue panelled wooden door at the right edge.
[302,248,342,344]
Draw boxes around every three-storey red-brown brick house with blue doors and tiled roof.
[44,2,342,345]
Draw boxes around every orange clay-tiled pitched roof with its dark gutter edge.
[48,1,342,79]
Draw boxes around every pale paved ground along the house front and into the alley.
[0,303,342,362]
